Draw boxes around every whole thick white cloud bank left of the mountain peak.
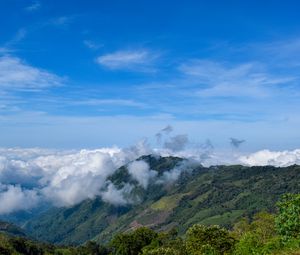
[0,143,149,214]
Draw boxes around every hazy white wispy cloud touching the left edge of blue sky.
[0,56,63,90]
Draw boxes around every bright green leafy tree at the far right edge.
[276,194,300,241]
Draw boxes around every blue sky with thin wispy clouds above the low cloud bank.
[0,0,300,150]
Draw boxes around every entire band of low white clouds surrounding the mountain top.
[0,127,300,215]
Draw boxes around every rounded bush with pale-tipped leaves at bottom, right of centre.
[186,224,235,254]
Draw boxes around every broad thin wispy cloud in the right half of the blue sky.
[180,60,297,97]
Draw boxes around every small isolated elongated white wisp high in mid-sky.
[96,49,158,72]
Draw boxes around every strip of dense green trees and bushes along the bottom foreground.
[0,194,300,255]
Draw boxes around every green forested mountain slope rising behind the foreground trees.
[26,156,300,244]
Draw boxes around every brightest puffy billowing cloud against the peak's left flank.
[38,149,123,206]
